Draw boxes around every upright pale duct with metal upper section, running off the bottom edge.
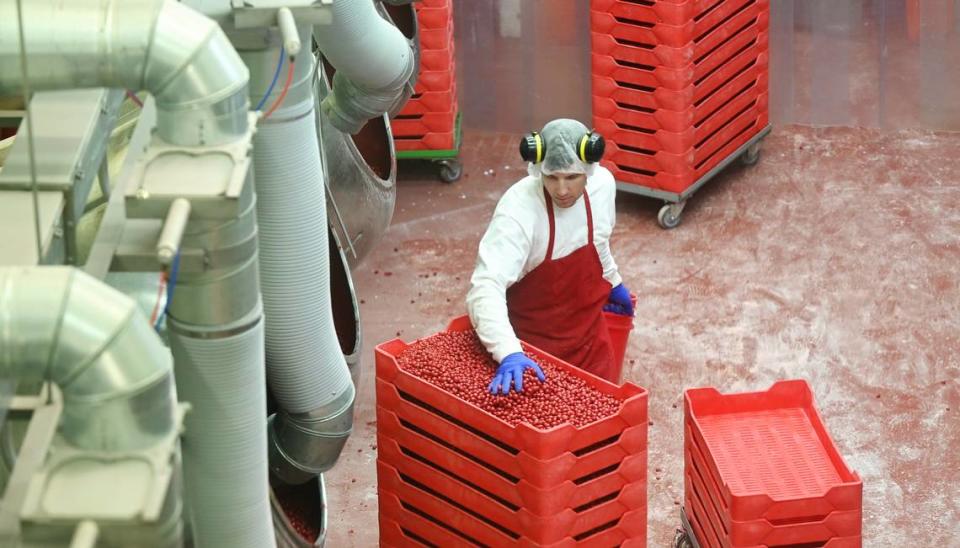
[167,162,274,548]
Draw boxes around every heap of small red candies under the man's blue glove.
[397,330,621,430]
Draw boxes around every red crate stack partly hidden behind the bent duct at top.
[391,0,458,151]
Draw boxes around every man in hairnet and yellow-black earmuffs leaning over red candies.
[467,119,633,394]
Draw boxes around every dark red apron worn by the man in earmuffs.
[507,189,617,382]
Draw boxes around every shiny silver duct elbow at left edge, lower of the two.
[0,267,176,452]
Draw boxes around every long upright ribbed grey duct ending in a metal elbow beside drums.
[240,31,356,483]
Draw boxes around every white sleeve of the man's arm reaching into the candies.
[467,212,532,363]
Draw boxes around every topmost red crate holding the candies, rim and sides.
[376,316,647,460]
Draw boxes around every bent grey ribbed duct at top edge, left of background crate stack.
[314,0,416,133]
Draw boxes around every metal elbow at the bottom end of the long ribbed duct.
[268,383,356,484]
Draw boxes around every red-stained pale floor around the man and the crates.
[327,127,960,547]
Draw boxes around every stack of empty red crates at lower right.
[684,381,863,548]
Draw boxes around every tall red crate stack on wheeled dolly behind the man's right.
[590,0,770,193]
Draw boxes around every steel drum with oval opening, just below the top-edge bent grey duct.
[316,56,397,268]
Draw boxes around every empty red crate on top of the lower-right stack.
[684,381,863,521]
